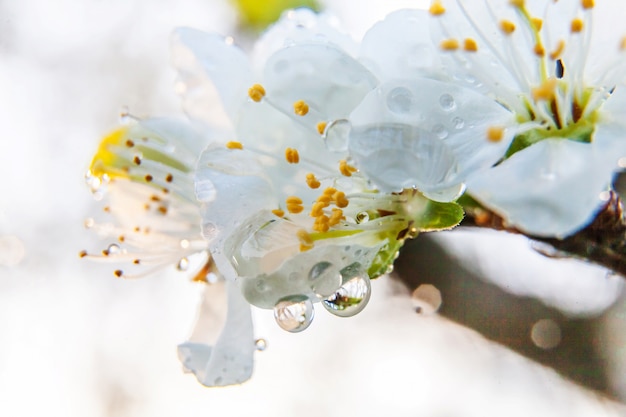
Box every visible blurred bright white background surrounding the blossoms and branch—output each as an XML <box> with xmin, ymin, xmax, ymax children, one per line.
<box><xmin>0</xmin><ymin>0</ymin><xmax>626</xmax><ymax>417</ymax></box>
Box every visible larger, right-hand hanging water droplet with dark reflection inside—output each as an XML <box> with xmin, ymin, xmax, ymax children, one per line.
<box><xmin>322</xmin><ymin>264</ymin><xmax>371</xmax><ymax>317</ymax></box>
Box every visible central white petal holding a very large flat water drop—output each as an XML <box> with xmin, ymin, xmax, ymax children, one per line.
<box><xmin>349</xmin><ymin>78</ymin><xmax>514</xmax><ymax>200</ymax></box>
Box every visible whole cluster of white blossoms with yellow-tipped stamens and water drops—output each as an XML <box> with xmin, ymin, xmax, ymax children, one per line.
<box><xmin>81</xmin><ymin>0</ymin><xmax>626</xmax><ymax>386</ymax></box>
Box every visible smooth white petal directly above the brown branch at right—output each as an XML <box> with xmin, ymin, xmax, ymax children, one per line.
<box><xmin>468</xmin><ymin>139</ymin><xmax>613</xmax><ymax>237</ymax></box>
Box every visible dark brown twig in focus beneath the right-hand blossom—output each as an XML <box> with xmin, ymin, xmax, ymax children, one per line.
<box><xmin>461</xmin><ymin>191</ymin><xmax>626</xmax><ymax>277</ymax></box>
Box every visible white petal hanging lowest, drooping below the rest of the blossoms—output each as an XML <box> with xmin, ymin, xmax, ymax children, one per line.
<box><xmin>178</xmin><ymin>282</ymin><xmax>255</xmax><ymax>387</ymax></box>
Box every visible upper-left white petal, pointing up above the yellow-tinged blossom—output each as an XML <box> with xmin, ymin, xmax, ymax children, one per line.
<box><xmin>172</xmin><ymin>28</ymin><xmax>253</xmax><ymax>128</ymax></box>
